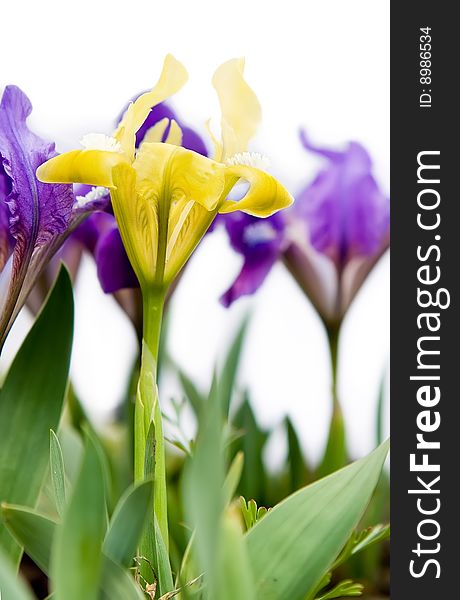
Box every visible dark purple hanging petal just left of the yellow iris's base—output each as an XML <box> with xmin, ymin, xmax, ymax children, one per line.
<box><xmin>95</xmin><ymin>225</ymin><xmax>139</xmax><ymax>294</ymax></box>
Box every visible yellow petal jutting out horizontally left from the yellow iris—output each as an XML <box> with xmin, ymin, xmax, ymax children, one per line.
<box><xmin>37</xmin><ymin>150</ymin><xmax>126</xmax><ymax>188</ymax></box>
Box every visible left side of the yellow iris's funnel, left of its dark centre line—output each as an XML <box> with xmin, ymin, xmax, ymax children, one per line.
<box><xmin>110</xmin><ymin>164</ymin><xmax>158</xmax><ymax>287</ymax></box>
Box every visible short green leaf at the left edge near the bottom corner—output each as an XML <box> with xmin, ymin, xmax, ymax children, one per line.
<box><xmin>2</xmin><ymin>504</ymin><xmax>57</xmax><ymax>575</ymax></box>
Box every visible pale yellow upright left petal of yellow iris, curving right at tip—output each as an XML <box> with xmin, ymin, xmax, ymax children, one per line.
<box><xmin>114</xmin><ymin>54</ymin><xmax>188</xmax><ymax>157</ymax></box>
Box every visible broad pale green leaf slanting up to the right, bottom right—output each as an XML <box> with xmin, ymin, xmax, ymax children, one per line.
<box><xmin>246</xmin><ymin>443</ymin><xmax>388</xmax><ymax>600</ymax></box>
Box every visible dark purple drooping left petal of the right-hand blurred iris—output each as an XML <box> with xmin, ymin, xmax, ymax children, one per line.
<box><xmin>221</xmin><ymin>212</ymin><xmax>285</xmax><ymax>306</ymax></box>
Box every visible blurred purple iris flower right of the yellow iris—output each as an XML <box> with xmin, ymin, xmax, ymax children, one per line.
<box><xmin>221</xmin><ymin>132</ymin><xmax>390</xmax><ymax>324</ymax></box>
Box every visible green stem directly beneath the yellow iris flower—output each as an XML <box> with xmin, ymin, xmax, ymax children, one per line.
<box><xmin>134</xmin><ymin>287</ymin><xmax>168</xmax><ymax>548</ymax></box>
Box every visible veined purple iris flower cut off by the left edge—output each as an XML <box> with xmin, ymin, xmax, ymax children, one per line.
<box><xmin>0</xmin><ymin>86</ymin><xmax>74</xmax><ymax>347</ymax></box>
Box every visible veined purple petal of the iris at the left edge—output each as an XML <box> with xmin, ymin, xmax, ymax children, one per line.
<box><xmin>0</xmin><ymin>86</ymin><xmax>74</xmax><ymax>272</ymax></box>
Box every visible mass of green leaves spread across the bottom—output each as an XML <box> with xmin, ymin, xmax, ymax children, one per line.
<box><xmin>0</xmin><ymin>284</ymin><xmax>389</xmax><ymax>600</ymax></box>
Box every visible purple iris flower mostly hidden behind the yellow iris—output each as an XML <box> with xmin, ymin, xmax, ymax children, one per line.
<box><xmin>72</xmin><ymin>98</ymin><xmax>207</xmax><ymax>294</ymax></box>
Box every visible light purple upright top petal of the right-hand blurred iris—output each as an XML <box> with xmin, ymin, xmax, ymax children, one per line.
<box><xmin>294</xmin><ymin>132</ymin><xmax>390</xmax><ymax>266</ymax></box>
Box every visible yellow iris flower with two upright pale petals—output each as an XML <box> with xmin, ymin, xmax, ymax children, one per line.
<box><xmin>37</xmin><ymin>55</ymin><xmax>292</xmax><ymax>291</ymax></box>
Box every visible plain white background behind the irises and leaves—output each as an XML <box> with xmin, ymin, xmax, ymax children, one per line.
<box><xmin>0</xmin><ymin>0</ymin><xmax>389</xmax><ymax>459</ymax></box>
